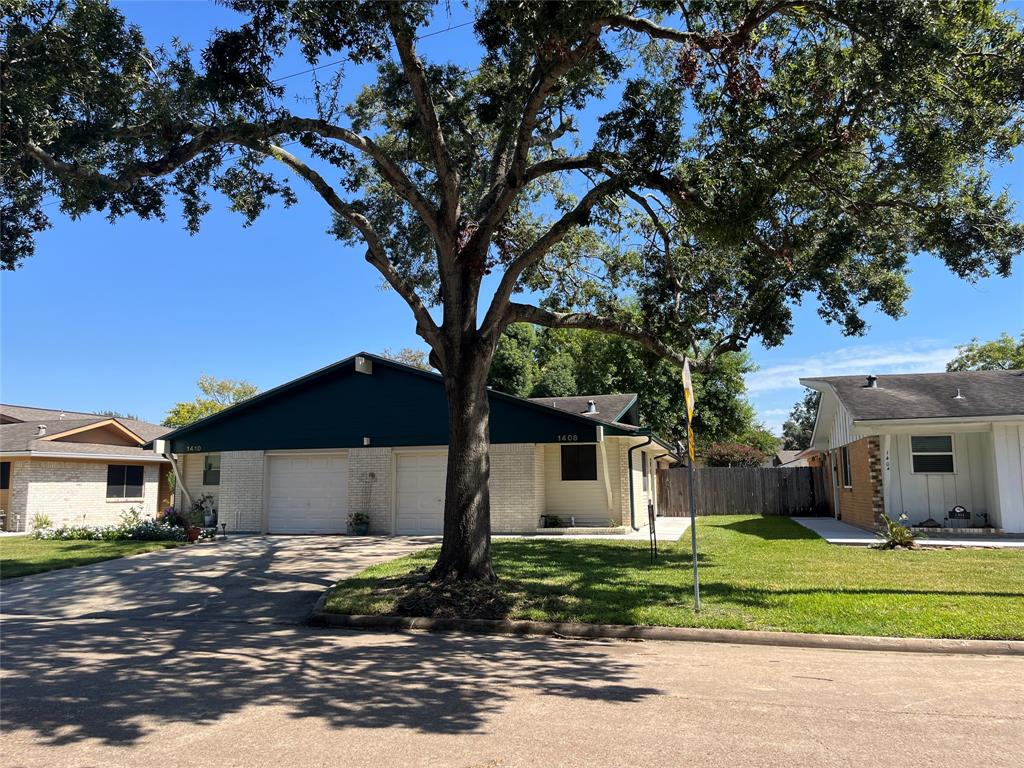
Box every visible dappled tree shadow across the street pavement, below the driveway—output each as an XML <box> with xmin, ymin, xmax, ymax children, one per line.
<box><xmin>2</xmin><ymin>617</ymin><xmax>658</xmax><ymax>745</ymax></box>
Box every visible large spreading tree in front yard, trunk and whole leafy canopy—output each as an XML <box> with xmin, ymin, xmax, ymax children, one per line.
<box><xmin>0</xmin><ymin>0</ymin><xmax>1024</xmax><ymax>580</ymax></box>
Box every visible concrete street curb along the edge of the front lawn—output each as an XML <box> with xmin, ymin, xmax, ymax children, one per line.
<box><xmin>309</xmin><ymin>606</ymin><xmax>1024</xmax><ymax>656</ymax></box>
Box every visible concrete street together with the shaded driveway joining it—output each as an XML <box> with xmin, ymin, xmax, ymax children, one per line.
<box><xmin>0</xmin><ymin>539</ymin><xmax>1024</xmax><ymax>768</ymax></box>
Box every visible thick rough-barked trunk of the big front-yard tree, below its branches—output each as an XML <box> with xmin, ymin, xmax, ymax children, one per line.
<box><xmin>430</xmin><ymin>353</ymin><xmax>495</xmax><ymax>582</ymax></box>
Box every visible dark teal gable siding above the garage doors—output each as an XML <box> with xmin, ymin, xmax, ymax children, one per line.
<box><xmin>160</xmin><ymin>357</ymin><xmax>623</xmax><ymax>454</ymax></box>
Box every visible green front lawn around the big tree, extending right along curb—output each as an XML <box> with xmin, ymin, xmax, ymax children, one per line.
<box><xmin>327</xmin><ymin>516</ymin><xmax>1024</xmax><ymax>639</ymax></box>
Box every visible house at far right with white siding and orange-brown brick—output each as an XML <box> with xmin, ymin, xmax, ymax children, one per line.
<box><xmin>801</xmin><ymin>371</ymin><xmax>1024</xmax><ymax>532</ymax></box>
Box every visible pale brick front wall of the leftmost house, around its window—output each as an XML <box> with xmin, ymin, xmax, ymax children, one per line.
<box><xmin>7</xmin><ymin>459</ymin><xmax>165</xmax><ymax>530</ymax></box>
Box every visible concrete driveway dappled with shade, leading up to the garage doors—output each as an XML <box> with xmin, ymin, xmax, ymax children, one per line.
<box><xmin>0</xmin><ymin>536</ymin><xmax>439</xmax><ymax>624</ymax></box>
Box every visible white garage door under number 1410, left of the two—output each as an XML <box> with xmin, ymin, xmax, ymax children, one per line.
<box><xmin>268</xmin><ymin>455</ymin><xmax>348</xmax><ymax>534</ymax></box>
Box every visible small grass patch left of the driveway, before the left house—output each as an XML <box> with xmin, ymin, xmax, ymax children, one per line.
<box><xmin>0</xmin><ymin>536</ymin><xmax>182</xmax><ymax>579</ymax></box>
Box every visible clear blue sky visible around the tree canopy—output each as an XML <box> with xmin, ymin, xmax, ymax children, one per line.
<box><xmin>0</xmin><ymin>1</ymin><xmax>1024</xmax><ymax>428</ymax></box>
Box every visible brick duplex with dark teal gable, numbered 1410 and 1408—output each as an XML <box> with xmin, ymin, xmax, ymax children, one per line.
<box><xmin>153</xmin><ymin>353</ymin><xmax>672</xmax><ymax>535</ymax></box>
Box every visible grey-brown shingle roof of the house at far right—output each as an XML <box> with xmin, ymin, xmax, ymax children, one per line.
<box><xmin>801</xmin><ymin>371</ymin><xmax>1024</xmax><ymax>421</ymax></box>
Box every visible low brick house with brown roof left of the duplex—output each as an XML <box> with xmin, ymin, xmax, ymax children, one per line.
<box><xmin>0</xmin><ymin>404</ymin><xmax>170</xmax><ymax>531</ymax></box>
